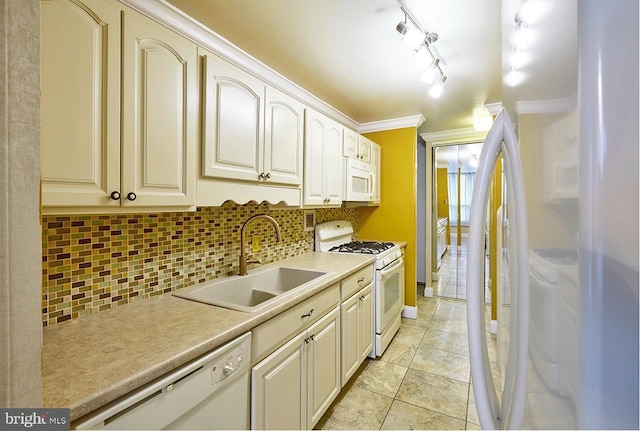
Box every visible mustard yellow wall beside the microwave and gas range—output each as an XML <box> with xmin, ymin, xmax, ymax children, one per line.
<box><xmin>358</xmin><ymin>127</ymin><xmax>418</xmax><ymax>306</ymax></box>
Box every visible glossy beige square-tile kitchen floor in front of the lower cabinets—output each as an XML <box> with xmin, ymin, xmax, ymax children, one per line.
<box><xmin>316</xmin><ymin>295</ymin><xmax>495</xmax><ymax>430</ymax></box>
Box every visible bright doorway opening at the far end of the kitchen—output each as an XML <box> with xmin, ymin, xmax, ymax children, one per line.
<box><xmin>431</xmin><ymin>143</ymin><xmax>482</xmax><ymax>299</ymax></box>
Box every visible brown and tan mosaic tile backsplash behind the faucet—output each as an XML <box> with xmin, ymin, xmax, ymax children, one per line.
<box><xmin>42</xmin><ymin>202</ymin><xmax>358</xmax><ymax>326</ymax></box>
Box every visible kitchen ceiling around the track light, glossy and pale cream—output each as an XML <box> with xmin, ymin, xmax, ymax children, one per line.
<box><xmin>168</xmin><ymin>0</ymin><xmax>501</xmax><ymax>133</ymax></box>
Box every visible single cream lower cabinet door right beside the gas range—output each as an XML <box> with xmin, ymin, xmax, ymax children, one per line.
<box><xmin>340</xmin><ymin>283</ymin><xmax>374</xmax><ymax>386</ymax></box>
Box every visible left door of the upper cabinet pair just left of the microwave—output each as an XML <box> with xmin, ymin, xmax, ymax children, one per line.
<box><xmin>303</xmin><ymin>109</ymin><xmax>327</xmax><ymax>205</ymax></box>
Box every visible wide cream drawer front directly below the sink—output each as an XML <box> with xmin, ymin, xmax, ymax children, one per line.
<box><xmin>251</xmin><ymin>283</ymin><xmax>340</xmax><ymax>364</ymax></box>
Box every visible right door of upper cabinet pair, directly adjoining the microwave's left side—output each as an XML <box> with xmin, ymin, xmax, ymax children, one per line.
<box><xmin>324</xmin><ymin>119</ymin><xmax>344</xmax><ymax>205</ymax></box>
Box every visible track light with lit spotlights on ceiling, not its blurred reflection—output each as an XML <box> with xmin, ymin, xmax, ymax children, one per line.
<box><xmin>396</xmin><ymin>6</ymin><xmax>447</xmax><ymax>99</ymax></box>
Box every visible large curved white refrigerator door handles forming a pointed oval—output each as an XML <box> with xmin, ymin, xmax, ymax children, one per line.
<box><xmin>467</xmin><ymin>109</ymin><xmax>529</xmax><ymax>429</ymax></box>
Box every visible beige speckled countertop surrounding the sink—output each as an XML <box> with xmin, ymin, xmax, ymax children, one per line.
<box><xmin>42</xmin><ymin>252</ymin><xmax>375</xmax><ymax>420</ymax></box>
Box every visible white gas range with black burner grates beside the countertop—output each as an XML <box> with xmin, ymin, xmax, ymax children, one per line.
<box><xmin>315</xmin><ymin>220</ymin><xmax>404</xmax><ymax>356</ymax></box>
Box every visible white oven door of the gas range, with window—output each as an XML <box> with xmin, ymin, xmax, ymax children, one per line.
<box><xmin>376</xmin><ymin>258</ymin><xmax>404</xmax><ymax>334</ymax></box>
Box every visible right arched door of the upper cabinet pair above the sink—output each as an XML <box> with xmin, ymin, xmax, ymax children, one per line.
<box><xmin>263</xmin><ymin>87</ymin><xmax>304</xmax><ymax>186</ymax></box>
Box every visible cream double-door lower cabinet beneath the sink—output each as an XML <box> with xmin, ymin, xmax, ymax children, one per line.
<box><xmin>251</xmin><ymin>307</ymin><xmax>341</xmax><ymax>429</ymax></box>
